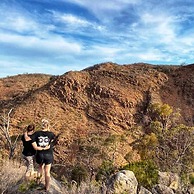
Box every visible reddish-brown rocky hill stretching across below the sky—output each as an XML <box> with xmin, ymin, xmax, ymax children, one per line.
<box><xmin>0</xmin><ymin>63</ymin><xmax>194</xmax><ymax>175</ymax></box>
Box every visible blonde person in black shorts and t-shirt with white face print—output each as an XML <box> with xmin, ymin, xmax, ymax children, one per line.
<box><xmin>32</xmin><ymin>119</ymin><xmax>55</xmax><ymax>191</ymax></box>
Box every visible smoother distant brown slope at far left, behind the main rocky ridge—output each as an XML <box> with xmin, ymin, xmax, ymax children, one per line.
<box><xmin>0</xmin><ymin>74</ymin><xmax>51</xmax><ymax>112</ymax></box>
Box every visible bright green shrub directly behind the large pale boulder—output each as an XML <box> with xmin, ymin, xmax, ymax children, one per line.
<box><xmin>122</xmin><ymin>161</ymin><xmax>158</xmax><ymax>189</ymax></box>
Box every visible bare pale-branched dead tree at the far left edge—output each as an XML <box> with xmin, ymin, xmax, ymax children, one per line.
<box><xmin>0</xmin><ymin>109</ymin><xmax>19</xmax><ymax>159</ymax></box>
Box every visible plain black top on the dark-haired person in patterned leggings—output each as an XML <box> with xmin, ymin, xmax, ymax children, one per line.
<box><xmin>21</xmin><ymin>135</ymin><xmax>36</xmax><ymax>156</ymax></box>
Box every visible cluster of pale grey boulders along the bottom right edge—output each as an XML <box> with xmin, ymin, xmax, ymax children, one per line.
<box><xmin>106</xmin><ymin>170</ymin><xmax>194</xmax><ymax>194</ymax></box>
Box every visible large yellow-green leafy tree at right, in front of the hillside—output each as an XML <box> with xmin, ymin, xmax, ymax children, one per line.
<box><xmin>136</xmin><ymin>104</ymin><xmax>194</xmax><ymax>173</ymax></box>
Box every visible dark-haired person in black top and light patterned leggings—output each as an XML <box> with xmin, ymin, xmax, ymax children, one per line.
<box><xmin>21</xmin><ymin>124</ymin><xmax>36</xmax><ymax>174</ymax></box>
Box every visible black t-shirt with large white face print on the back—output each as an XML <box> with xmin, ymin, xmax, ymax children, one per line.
<box><xmin>31</xmin><ymin>131</ymin><xmax>55</xmax><ymax>154</ymax></box>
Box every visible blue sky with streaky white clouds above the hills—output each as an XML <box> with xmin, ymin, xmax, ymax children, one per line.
<box><xmin>0</xmin><ymin>0</ymin><xmax>194</xmax><ymax>77</ymax></box>
